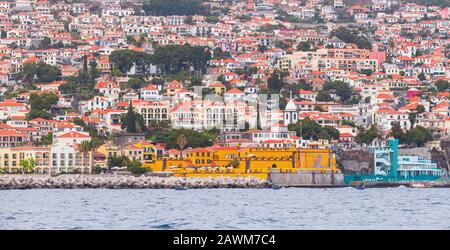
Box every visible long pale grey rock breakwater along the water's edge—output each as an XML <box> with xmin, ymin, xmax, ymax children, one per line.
<box><xmin>0</xmin><ymin>175</ymin><xmax>269</xmax><ymax>189</ymax></box>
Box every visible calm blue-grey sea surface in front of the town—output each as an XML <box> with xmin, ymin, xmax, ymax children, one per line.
<box><xmin>0</xmin><ymin>187</ymin><xmax>450</xmax><ymax>229</ymax></box>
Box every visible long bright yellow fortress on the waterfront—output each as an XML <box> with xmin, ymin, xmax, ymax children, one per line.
<box><xmin>135</xmin><ymin>144</ymin><xmax>339</xmax><ymax>179</ymax></box>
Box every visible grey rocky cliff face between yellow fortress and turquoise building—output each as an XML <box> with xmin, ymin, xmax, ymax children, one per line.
<box><xmin>337</xmin><ymin>150</ymin><xmax>373</xmax><ymax>174</ymax></box>
